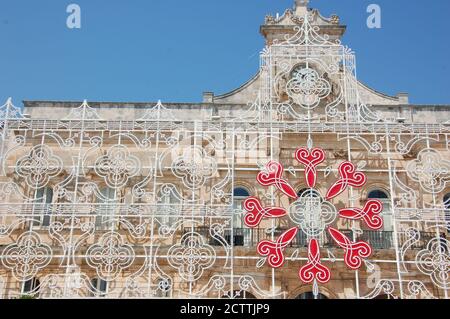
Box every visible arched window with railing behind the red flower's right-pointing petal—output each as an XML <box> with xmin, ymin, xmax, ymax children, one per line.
<box><xmin>368</xmin><ymin>189</ymin><xmax>394</xmax><ymax>249</ymax></box>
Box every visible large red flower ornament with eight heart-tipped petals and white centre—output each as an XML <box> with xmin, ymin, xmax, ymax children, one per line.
<box><xmin>243</xmin><ymin>148</ymin><xmax>383</xmax><ymax>285</ymax></box>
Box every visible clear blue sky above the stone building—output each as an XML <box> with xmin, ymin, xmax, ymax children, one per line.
<box><xmin>0</xmin><ymin>0</ymin><xmax>450</xmax><ymax>106</ymax></box>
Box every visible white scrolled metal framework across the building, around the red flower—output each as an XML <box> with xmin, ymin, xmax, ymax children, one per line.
<box><xmin>0</xmin><ymin>12</ymin><xmax>450</xmax><ymax>299</ymax></box>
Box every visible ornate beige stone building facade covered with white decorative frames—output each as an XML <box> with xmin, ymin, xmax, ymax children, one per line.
<box><xmin>0</xmin><ymin>0</ymin><xmax>450</xmax><ymax>299</ymax></box>
